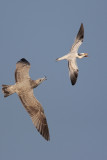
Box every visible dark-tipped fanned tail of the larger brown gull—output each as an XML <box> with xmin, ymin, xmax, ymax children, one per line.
<box><xmin>2</xmin><ymin>84</ymin><xmax>15</xmax><ymax>97</ymax></box>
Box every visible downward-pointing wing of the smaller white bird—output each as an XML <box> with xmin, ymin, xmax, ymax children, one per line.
<box><xmin>68</xmin><ymin>60</ymin><xmax>78</xmax><ymax>85</ymax></box>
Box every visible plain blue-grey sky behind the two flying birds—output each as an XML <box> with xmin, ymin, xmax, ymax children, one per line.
<box><xmin>0</xmin><ymin>0</ymin><xmax>107</xmax><ymax>160</ymax></box>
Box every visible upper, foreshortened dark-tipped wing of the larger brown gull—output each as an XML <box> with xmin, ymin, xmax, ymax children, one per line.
<box><xmin>15</xmin><ymin>58</ymin><xmax>30</xmax><ymax>82</ymax></box>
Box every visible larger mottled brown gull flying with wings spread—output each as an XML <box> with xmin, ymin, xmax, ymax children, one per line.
<box><xmin>2</xmin><ymin>58</ymin><xmax>50</xmax><ymax>140</ymax></box>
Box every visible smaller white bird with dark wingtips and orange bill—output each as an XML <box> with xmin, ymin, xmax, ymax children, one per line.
<box><xmin>56</xmin><ymin>24</ymin><xmax>88</xmax><ymax>85</ymax></box>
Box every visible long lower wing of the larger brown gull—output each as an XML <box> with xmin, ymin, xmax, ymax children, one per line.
<box><xmin>19</xmin><ymin>90</ymin><xmax>50</xmax><ymax>140</ymax></box>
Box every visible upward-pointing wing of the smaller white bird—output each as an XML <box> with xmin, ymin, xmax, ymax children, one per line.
<box><xmin>71</xmin><ymin>23</ymin><xmax>84</xmax><ymax>54</ymax></box>
